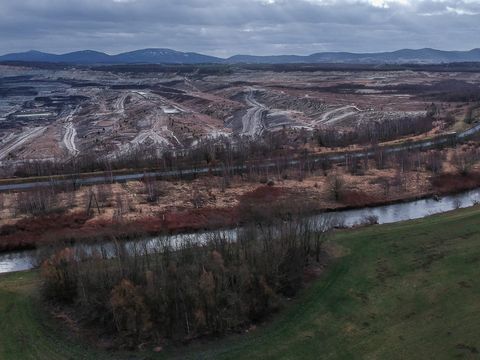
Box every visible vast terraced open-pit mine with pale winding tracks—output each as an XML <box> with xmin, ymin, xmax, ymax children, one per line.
<box><xmin>0</xmin><ymin>65</ymin><xmax>480</xmax><ymax>170</ymax></box>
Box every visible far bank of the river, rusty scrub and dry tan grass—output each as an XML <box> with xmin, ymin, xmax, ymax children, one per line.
<box><xmin>0</xmin><ymin>165</ymin><xmax>480</xmax><ymax>253</ymax></box>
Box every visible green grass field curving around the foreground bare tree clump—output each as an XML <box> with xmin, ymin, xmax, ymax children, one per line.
<box><xmin>0</xmin><ymin>207</ymin><xmax>480</xmax><ymax>360</ymax></box>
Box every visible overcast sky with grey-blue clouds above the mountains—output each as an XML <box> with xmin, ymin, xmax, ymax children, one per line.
<box><xmin>0</xmin><ymin>0</ymin><xmax>480</xmax><ymax>56</ymax></box>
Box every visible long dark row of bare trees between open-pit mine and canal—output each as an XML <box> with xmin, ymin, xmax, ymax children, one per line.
<box><xmin>0</xmin><ymin>116</ymin><xmax>458</xmax><ymax>186</ymax></box>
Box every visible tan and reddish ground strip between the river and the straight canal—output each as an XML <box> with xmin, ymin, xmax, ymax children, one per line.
<box><xmin>0</xmin><ymin>150</ymin><xmax>480</xmax><ymax>251</ymax></box>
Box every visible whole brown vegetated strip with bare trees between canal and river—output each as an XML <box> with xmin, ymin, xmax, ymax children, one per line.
<box><xmin>0</xmin><ymin>143</ymin><xmax>480</xmax><ymax>251</ymax></box>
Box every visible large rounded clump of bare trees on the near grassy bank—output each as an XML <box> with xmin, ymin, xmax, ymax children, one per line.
<box><xmin>42</xmin><ymin>212</ymin><xmax>331</xmax><ymax>346</ymax></box>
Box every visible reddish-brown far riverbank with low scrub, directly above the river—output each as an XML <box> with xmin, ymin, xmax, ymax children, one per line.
<box><xmin>0</xmin><ymin>167</ymin><xmax>480</xmax><ymax>253</ymax></box>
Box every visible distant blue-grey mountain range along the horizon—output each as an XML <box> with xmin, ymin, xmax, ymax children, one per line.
<box><xmin>0</xmin><ymin>48</ymin><xmax>480</xmax><ymax>65</ymax></box>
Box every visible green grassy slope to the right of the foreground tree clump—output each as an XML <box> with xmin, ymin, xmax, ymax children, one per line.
<box><xmin>189</xmin><ymin>208</ymin><xmax>480</xmax><ymax>359</ymax></box>
